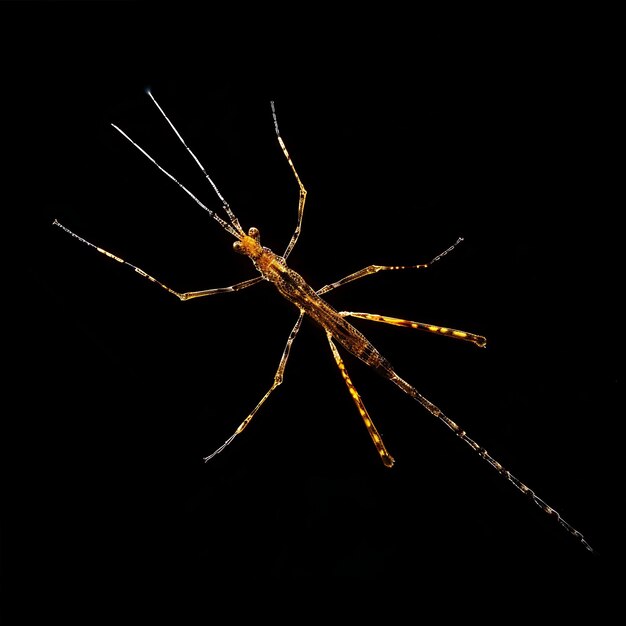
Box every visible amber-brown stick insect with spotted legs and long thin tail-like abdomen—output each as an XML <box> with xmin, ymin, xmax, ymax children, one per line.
<box><xmin>53</xmin><ymin>90</ymin><xmax>593</xmax><ymax>552</ymax></box>
